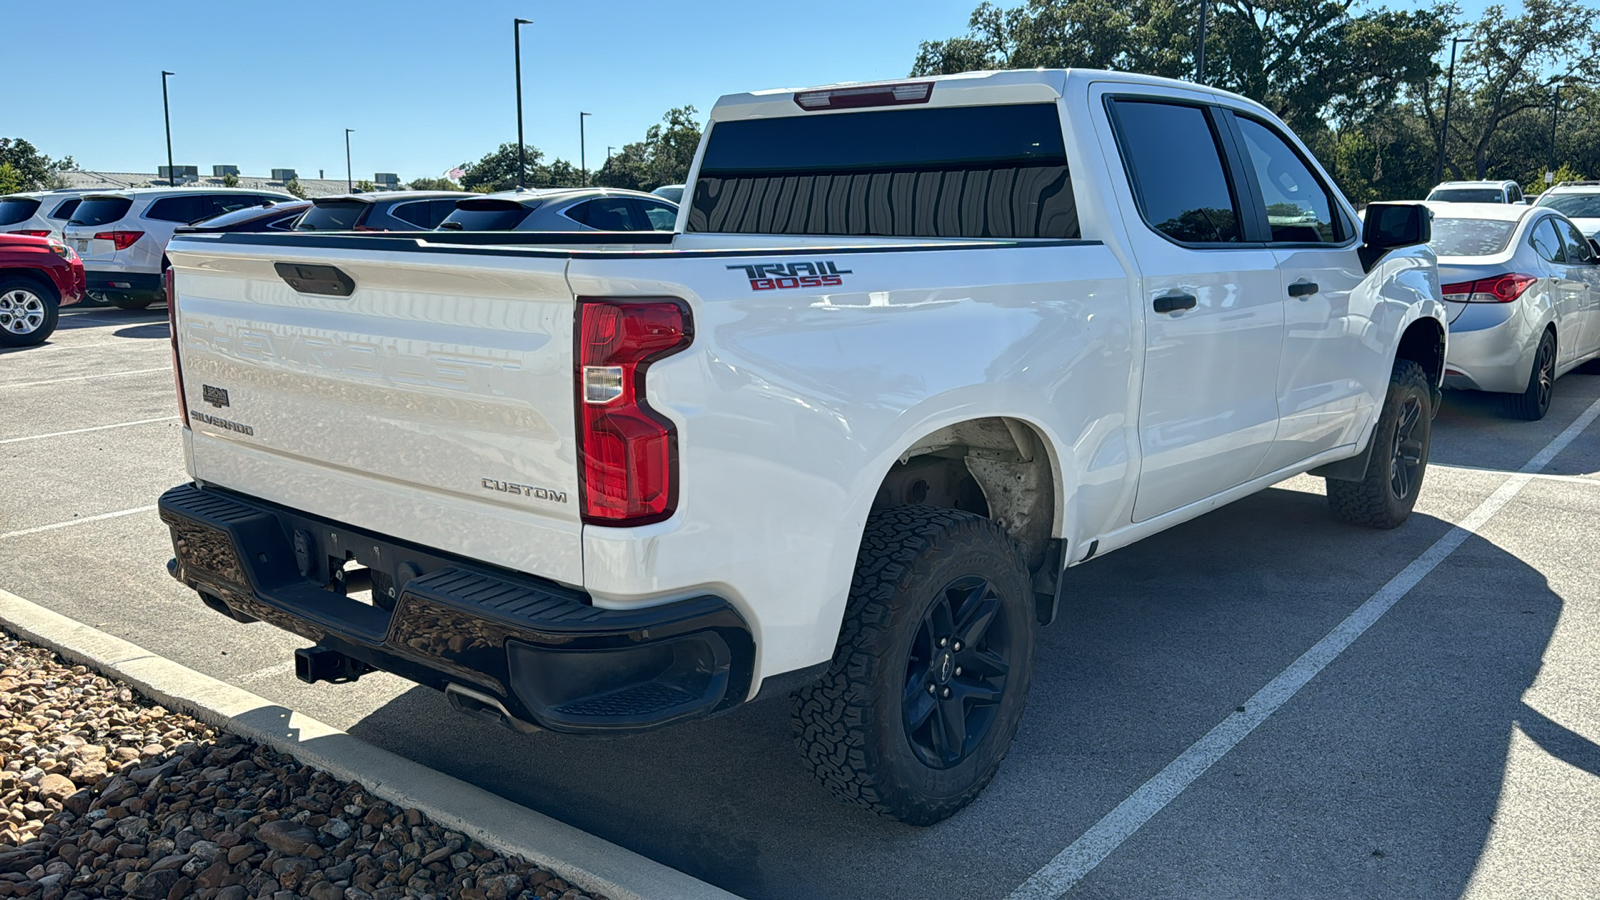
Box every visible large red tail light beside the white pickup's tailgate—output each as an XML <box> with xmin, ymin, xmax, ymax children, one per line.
<box><xmin>576</xmin><ymin>298</ymin><xmax>693</xmax><ymax>525</ymax></box>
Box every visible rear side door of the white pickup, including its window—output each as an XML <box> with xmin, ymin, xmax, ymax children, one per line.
<box><xmin>1109</xmin><ymin>96</ymin><xmax>1283</xmax><ymax>522</ymax></box>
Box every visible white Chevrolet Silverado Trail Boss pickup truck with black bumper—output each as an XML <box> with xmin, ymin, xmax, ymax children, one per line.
<box><xmin>160</xmin><ymin>70</ymin><xmax>1446</xmax><ymax>823</ymax></box>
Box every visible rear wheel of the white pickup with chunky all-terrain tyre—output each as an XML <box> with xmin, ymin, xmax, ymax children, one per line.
<box><xmin>790</xmin><ymin>506</ymin><xmax>1034</xmax><ymax>825</ymax></box>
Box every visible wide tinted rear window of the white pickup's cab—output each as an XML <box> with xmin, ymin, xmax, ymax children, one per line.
<box><xmin>688</xmin><ymin>104</ymin><xmax>1078</xmax><ymax>239</ymax></box>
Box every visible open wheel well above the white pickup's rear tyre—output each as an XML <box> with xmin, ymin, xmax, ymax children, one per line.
<box><xmin>872</xmin><ymin>416</ymin><xmax>1059</xmax><ymax>570</ymax></box>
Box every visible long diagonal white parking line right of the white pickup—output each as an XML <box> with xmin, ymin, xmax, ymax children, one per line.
<box><xmin>1011</xmin><ymin>393</ymin><xmax>1600</xmax><ymax>900</ymax></box>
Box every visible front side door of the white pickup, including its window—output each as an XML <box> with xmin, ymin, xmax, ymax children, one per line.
<box><xmin>1226</xmin><ymin>112</ymin><xmax>1387</xmax><ymax>474</ymax></box>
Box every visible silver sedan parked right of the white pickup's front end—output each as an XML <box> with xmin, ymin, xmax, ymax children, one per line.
<box><xmin>1427</xmin><ymin>203</ymin><xmax>1600</xmax><ymax>420</ymax></box>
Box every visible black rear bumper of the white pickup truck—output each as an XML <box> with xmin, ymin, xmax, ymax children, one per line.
<box><xmin>160</xmin><ymin>485</ymin><xmax>755</xmax><ymax>733</ymax></box>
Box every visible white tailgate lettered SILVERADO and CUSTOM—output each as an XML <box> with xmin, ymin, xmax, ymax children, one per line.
<box><xmin>170</xmin><ymin>239</ymin><xmax>582</xmax><ymax>585</ymax></box>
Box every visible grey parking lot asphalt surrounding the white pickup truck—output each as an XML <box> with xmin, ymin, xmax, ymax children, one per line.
<box><xmin>9</xmin><ymin>309</ymin><xmax>1600</xmax><ymax>900</ymax></box>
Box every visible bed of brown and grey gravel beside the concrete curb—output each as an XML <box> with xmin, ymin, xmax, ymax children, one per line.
<box><xmin>0</xmin><ymin>633</ymin><xmax>603</xmax><ymax>900</ymax></box>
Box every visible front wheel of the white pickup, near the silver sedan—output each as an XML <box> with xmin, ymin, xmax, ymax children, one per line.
<box><xmin>1328</xmin><ymin>359</ymin><xmax>1434</xmax><ymax>528</ymax></box>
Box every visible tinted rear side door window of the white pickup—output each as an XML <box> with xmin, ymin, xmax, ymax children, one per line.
<box><xmin>1112</xmin><ymin>101</ymin><xmax>1243</xmax><ymax>243</ymax></box>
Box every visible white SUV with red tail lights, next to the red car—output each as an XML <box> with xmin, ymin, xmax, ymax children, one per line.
<box><xmin>62</xmin><ymin>187</ymin><xmax>294</xmax><ymax>309</ymax></box>
